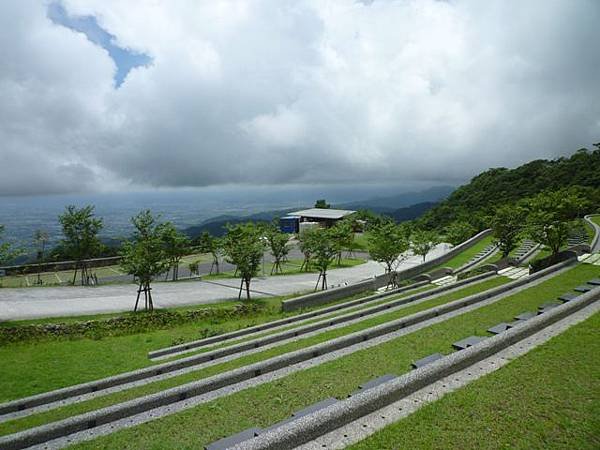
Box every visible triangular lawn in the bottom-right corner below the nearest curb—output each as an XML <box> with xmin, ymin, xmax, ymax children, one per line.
<box><xmin>350</xmin><ymin>313</ymin><xmax>600</xmax><ymax>450</ymax></box>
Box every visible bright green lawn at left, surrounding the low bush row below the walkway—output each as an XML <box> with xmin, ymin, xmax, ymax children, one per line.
<box><xmin>0</xmin><ymin>295</ymin><xmax>318</xmax><ymax>402</ymax></box>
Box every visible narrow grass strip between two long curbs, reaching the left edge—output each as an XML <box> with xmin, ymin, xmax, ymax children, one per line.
<box><xmin>0</xmin><ymin>277</ymin><xmax>510</xmax><ymax>435</ymax></box>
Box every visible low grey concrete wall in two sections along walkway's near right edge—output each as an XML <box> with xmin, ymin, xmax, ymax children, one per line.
<box><xmin>281</xmin><ymin>229</ymin><xmax>492</xmax><ymax>311</ymax></box>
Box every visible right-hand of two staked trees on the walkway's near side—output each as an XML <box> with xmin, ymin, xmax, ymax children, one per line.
<box><xmin>223</xmin><ymin>222</ymin><xmax>265</xmax><ymax>300</ymax></box>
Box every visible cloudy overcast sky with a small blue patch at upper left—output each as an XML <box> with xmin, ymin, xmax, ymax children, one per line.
<box><xmin>0</xmin><ymin>0</ymin><xmax>600</xmax><ymax>195</ymax></box>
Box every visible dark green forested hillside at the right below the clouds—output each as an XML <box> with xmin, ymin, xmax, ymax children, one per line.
<box><xmin>419</xmin><ymin>144</ymin><xmax>600</xmax><ymax>229</ymax></box>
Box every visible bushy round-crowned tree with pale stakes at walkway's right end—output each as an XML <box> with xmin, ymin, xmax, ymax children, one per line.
<box><xmin>367</xmin><ymin>222</ymin><xmax>410</xmax><ymax>273</ymax></box>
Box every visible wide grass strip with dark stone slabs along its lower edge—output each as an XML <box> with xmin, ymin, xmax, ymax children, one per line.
<box><xmin>59</xmin><ymin>264</ymin><xmax>598</xmax><ymax>449</ymax></box>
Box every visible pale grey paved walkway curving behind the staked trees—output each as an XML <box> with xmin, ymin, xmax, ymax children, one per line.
<box><xmin>0</xmin><ymin>244</ymin><xmax>449</xmax><ymax>321</ymax></box>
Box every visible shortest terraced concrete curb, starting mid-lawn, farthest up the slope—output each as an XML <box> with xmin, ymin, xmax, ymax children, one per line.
<box><xmin>148</xmin><ymin>280</ymin><xmax>429</xmax><ymax>359</ymax></box>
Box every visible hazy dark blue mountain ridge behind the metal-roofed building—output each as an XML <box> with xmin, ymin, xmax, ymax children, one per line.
<box><xmin>183</xmin><ymin>186</ymin><xmax>454</xmax><ymax>237</ymax></box>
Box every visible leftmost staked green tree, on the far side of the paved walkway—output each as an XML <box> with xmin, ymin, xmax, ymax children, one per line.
<box><xmin>58</xmin><ymin>205</ymin><xmax>103</xmax><ymax>285</ymax></box>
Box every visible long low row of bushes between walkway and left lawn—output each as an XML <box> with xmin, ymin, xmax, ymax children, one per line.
<box><xmin>0</xmin><ymin>303</ymin><xmax>264</xmax><ymax>345</ymax></box>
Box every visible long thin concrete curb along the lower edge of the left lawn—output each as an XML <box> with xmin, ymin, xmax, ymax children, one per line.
<box><xmin>0</xmin><ymin>273</ymin><xmax>493</xmax><ymax>415</ymax></box>
